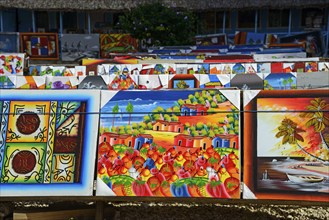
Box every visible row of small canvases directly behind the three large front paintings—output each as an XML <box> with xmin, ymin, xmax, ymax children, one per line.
<box><xmin>0</xmin><ymin>72</ymin><xmax>329</xmax><ymax>90</ymax></box>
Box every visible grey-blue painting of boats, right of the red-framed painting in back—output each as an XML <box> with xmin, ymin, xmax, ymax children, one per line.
<box><xmin>61</xmin><ymin>34</ymin><xmax>100</xmax><ymax>62</ymax></box>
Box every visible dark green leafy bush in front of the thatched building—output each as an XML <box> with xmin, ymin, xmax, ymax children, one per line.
<box><xmin>118</xmin><ymin>2</ymin><xmax>196</xmax><ymax>46</ymax></box>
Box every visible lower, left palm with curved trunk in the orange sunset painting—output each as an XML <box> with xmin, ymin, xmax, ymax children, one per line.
<box><xmin>275</xmin><ymin>118</ymin><xmax>328</xmax><ymax>162</ymax></box>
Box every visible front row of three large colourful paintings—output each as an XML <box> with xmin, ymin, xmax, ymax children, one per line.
<box><xmin>0</xmin><ymin>89</ymin><xmax>329</xmax><ymax>202</ymax></box>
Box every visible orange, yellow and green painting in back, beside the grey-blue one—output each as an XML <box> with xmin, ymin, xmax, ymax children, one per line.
<box><xmin>100</xmin><ymin>34</ymin><xmax>138</xmax><ymax>58</ymax></box>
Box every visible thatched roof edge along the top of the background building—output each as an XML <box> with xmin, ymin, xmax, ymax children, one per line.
<box><xmin>0</xmin><ymin>0</ymin><xmax>329</xmax><ymax>11</ymax></box>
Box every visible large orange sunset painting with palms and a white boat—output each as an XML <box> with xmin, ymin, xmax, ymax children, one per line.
<box><xmin>243</xmin><ymin>89</ymin><xmax>329</xmax><ymax>202</ymax></box>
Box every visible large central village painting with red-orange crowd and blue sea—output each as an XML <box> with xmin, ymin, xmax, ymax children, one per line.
<box><xmin>96</xmin><ymin>90</ymin><xmax>241</xmax><ymax>199</ymax></box>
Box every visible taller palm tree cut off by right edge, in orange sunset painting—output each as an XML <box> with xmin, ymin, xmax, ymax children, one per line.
<box><xmin>300</xmin><ymin>98</ymin><xmax>329</xmax><ymax>150</ymax></box>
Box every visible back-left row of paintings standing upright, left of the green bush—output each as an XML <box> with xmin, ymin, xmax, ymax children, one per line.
<box><xmin>0</xmin><ymin>32</ymin><xmax>138</xmax><ymax>62</ymax></box>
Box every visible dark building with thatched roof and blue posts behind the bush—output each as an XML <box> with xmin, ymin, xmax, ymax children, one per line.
<box><xmin>0</xmin><ymin>0</ymin><xmax>329</xmax><ymax>53</ymax></box>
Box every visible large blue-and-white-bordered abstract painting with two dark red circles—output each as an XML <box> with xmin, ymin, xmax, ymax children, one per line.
<box><xmin>0</xmin><ymin>90</ymin><xmax>100</xmax><ymax>196</ymax></box>
